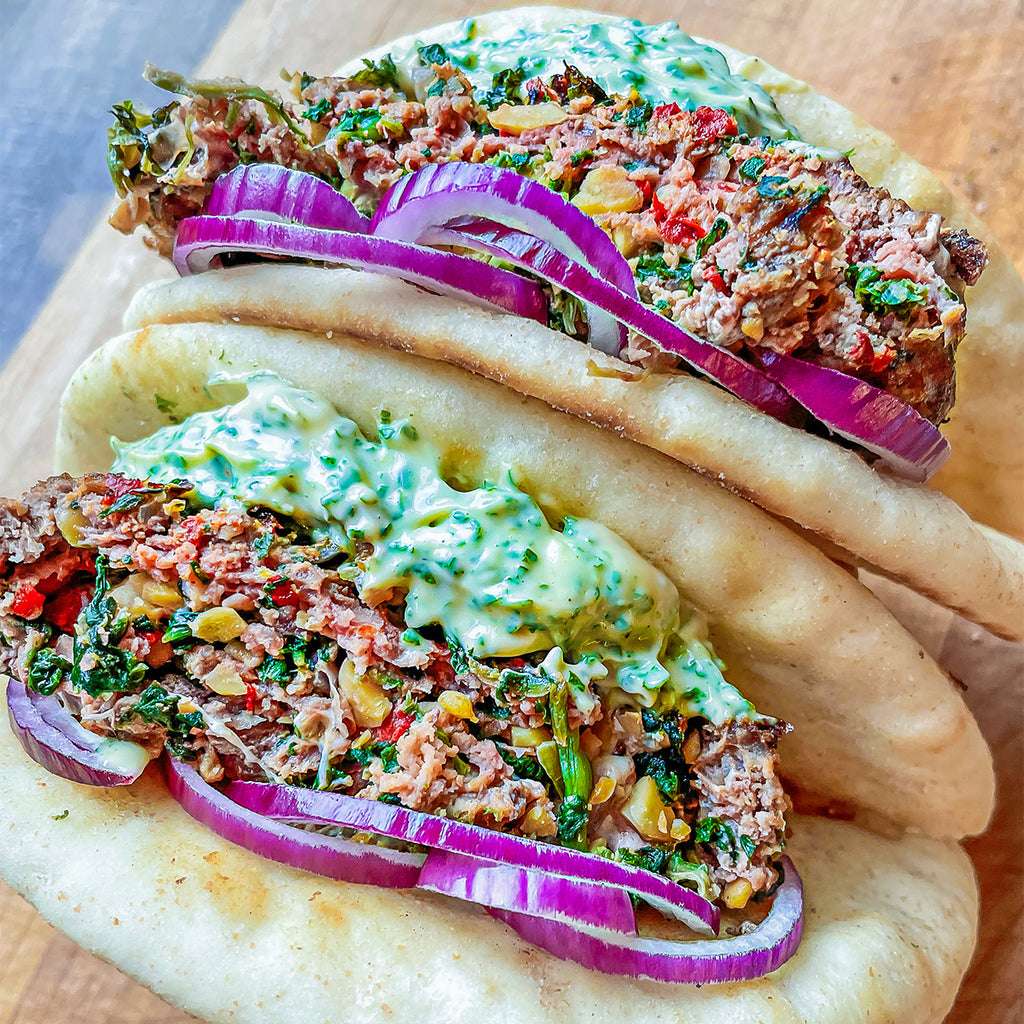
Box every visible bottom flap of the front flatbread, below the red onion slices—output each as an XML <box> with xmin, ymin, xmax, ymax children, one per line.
<box><xmin>0</xmin><ymin>716</ymin><xmax>978</xmax><ymax>1024</ymax></box>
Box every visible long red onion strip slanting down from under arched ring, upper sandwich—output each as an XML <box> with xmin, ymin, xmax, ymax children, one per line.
<box><xmin>417</xmin><ymin>217</ymin><xmax>798</xmax><ymax>421</ymax></box>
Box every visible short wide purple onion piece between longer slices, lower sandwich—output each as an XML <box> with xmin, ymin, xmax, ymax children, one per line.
<box><xmin>418</xmin><ymin>850</ymin><xmax>637</xmax><ymax>935</ymax></box>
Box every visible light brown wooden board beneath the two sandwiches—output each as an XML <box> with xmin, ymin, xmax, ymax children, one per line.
<box><xmin>0</xmin><ymin>0</ymin><xmax>1024</xmax><ymax>1024</ymax></box>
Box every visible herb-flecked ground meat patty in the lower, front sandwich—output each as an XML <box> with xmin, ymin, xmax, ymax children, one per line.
<box><xmin>0</xmin><ymin>474</ymin><xmax>785</xmax><ymax>905</ymax></box>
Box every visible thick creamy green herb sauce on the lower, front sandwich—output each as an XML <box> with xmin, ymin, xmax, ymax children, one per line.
<box><xmin>113</xmin><ymin>374</ymin><xmax>754</xmax><ymax>723</ymax></box>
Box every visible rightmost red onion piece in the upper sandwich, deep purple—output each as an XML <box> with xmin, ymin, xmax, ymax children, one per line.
<box><xmin>754</xmin><ymin>348</ymin><xmax>949</xmax><ymax>483</ymax></box>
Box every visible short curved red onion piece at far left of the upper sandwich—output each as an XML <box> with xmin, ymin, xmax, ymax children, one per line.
<box><xmin>203</xmin><ymin>164</ymin><xmax>370</xmax><ymax>233</ymax></box>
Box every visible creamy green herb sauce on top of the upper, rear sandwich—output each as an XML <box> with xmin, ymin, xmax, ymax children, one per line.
<box><xmin>392</xmin><ymin>13</ymin><xmax>798</xmax><ymax>138</ymax></box>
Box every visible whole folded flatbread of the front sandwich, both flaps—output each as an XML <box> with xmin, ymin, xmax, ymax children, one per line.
<box><xmin>0</xmin><ymin>315</ymin><xmax>991</xmax><ymax>1022</ymax></box>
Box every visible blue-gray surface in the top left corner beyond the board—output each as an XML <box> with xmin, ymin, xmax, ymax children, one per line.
<box><xmin>0</xmin><ymin>0</ymin><xmax>240</xmax><ymax>367</ymax></box>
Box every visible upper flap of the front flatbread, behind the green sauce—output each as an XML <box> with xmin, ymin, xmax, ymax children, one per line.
<box><xmin>56</xmin><ymin>324</ymin><xmax>993</xmax><ymax>837</ymax></box>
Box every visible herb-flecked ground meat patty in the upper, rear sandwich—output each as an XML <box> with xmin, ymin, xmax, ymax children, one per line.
<box><xmin>112</xmin><ymin>65</ymin><xmax>988</xmax><ymax>423</ymax></box>
